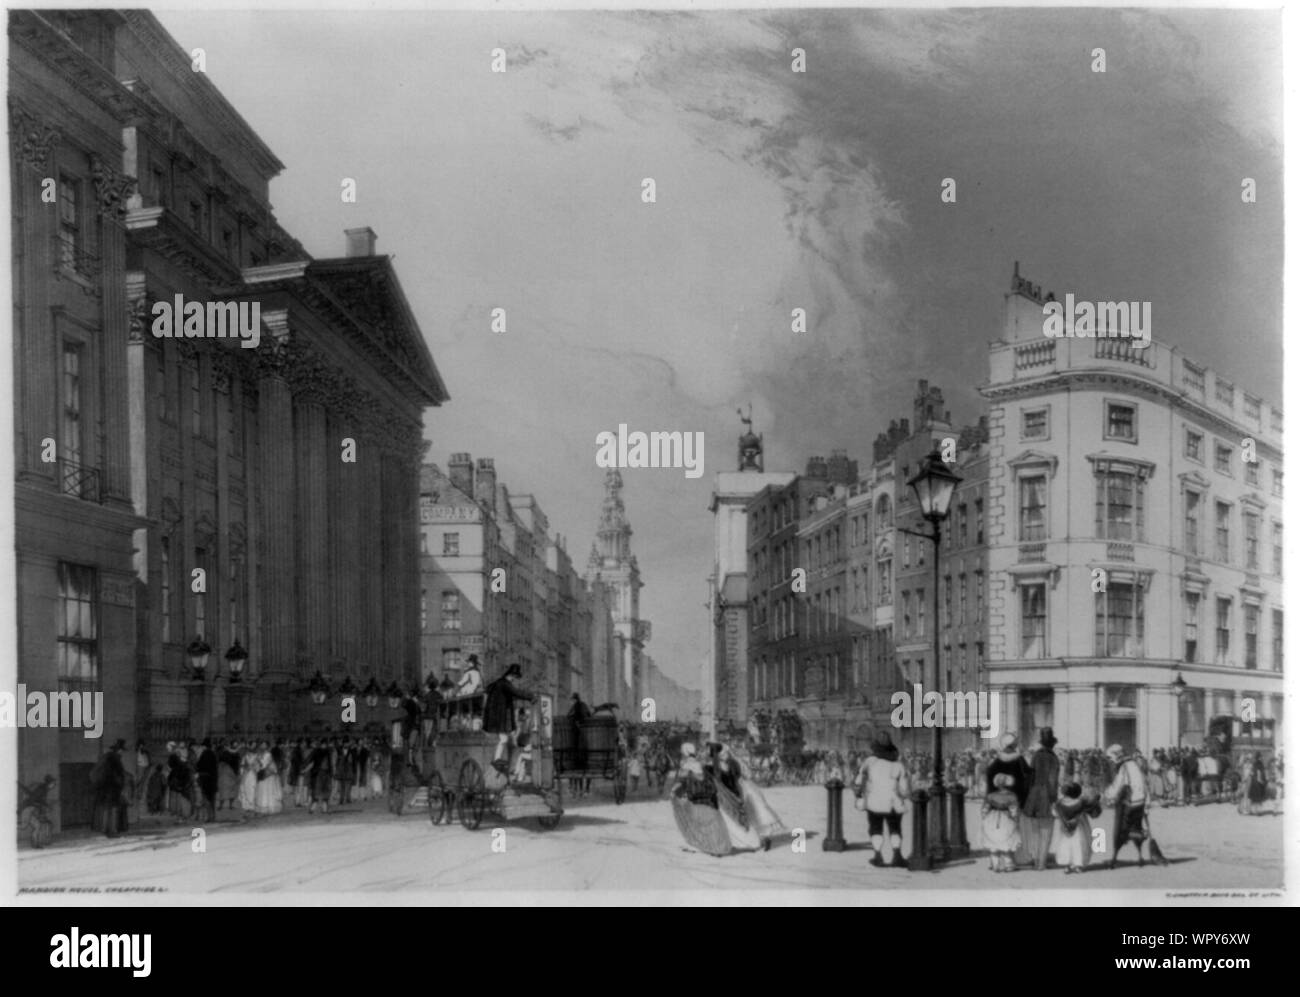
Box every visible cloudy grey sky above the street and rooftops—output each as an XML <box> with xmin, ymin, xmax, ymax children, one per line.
<box><xmin>160</xmin><ymin>9</ymin><xmax>1282</xmax><ymax>685</ymax></box>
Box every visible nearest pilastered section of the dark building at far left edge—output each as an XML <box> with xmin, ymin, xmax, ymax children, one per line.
<box><xmin>3</xmin><ymin>10</ymin><xmax>146</xmax><ymax>829</ymax></box>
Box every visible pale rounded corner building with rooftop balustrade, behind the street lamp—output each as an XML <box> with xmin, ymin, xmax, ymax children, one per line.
<box><xmin>982</xmin><ymin>268</ymin><xmax>1284</xmax><ymax>753</ymax></box>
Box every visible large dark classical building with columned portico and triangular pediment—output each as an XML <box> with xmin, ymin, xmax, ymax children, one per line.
<box><xmin>10</xmin><ymin>10</ymin><xmax>447</xmax><ymax>823</ymax></box>
